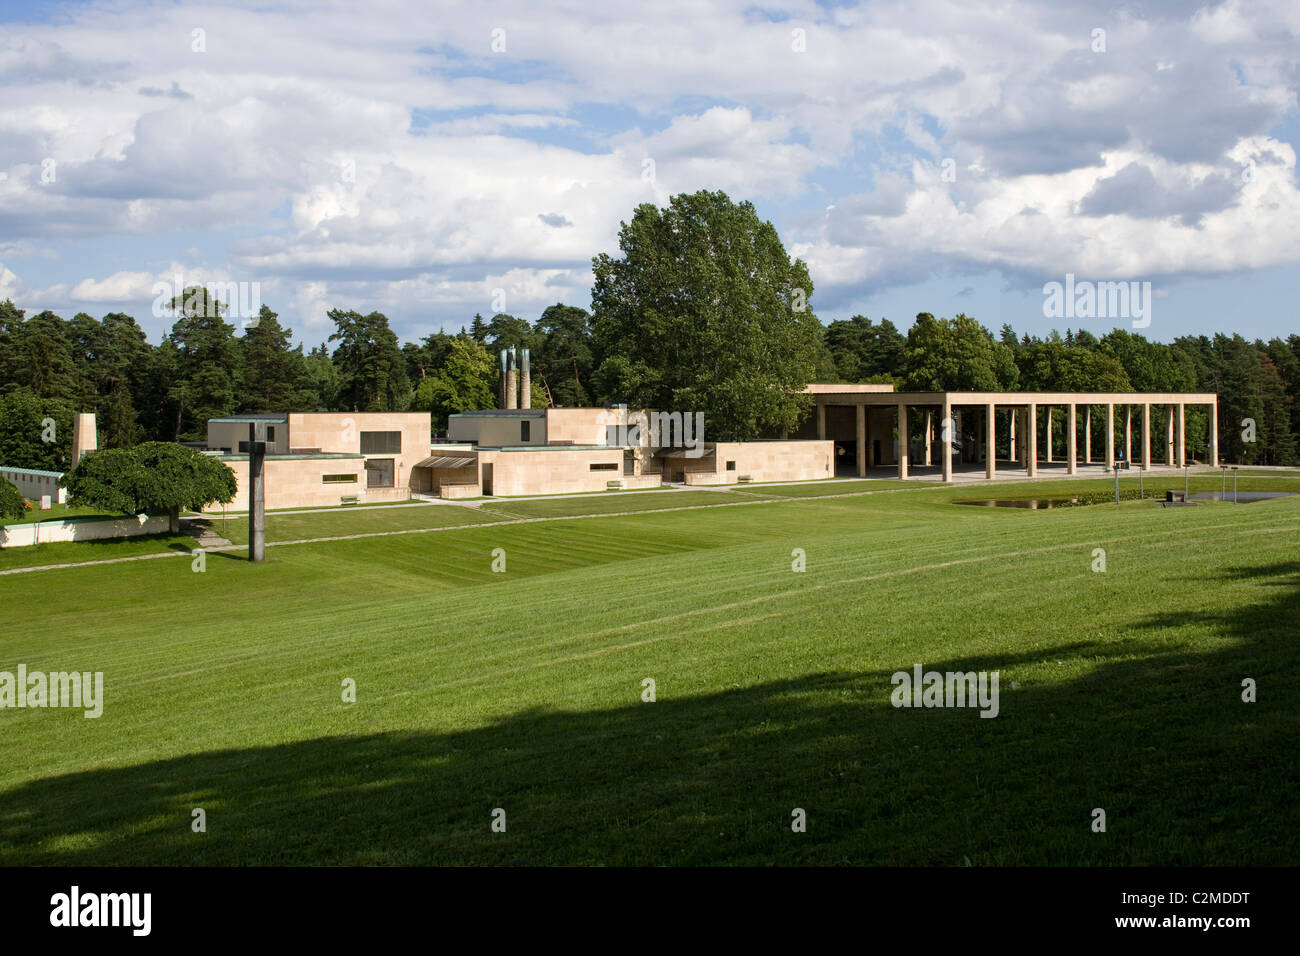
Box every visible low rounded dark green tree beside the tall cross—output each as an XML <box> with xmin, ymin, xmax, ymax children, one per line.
<box><xmin>60</xmin><ymin>441</ymin><xmax>238</xmax><ymax>533</ymax></box>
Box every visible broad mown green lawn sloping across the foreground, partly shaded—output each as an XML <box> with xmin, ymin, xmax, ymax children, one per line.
<box><xmin>0</xmin><ymin>475</ymin><xmax>1300</xmax><ymax>865</ymax></box>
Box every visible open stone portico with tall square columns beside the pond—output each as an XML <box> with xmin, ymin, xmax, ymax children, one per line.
<box><xmin>806</xmin><ymin>385</ymin><xmax>1218</xmax><ymax>481</ymax></box>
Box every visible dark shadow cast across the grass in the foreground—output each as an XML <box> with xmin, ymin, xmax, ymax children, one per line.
<box><xmin>0</xmin><ymin>562</ymin><xmax>1300</xmax><ymax>865</ymax></box>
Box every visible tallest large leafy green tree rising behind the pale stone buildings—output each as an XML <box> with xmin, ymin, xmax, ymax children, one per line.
<box><xmin>592</xmin><ymin>191</ymin><xmax>822</xmax><ymax>440</ymax></box>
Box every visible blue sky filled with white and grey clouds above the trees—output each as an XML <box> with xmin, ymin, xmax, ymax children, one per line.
<box><xmin>0</xmin><ymin>0</ymin><xmax>1300</xmax><ymax>345</ymax></box>
